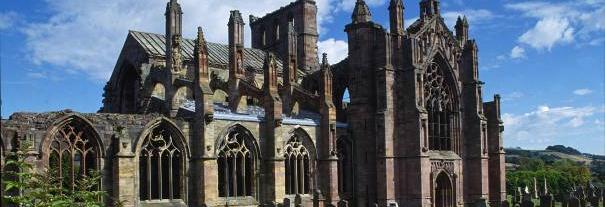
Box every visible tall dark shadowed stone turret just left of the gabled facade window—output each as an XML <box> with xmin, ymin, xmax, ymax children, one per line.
<box><xmin>345</xmin><ymin>0</ymin><xmax>397</xmax><ymax>206</ymax></box>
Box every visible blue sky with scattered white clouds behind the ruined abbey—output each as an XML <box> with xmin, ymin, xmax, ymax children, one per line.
<box><xmin>0</xmin><ymin>0</ymin><xmax>605</xmax><ymax>154</ymax></box>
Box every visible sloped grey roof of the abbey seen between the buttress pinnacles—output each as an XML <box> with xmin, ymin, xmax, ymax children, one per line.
<box><xmin>129</xmin><ymin>31</ymin><xmax>282</xmax><ymax>71</ymax></box>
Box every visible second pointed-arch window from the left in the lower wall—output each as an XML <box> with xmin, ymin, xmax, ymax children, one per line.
<box><xmin>139</xmin><ymin>122</ymin><xmax>185</xmax><ymax>200</ymax></box>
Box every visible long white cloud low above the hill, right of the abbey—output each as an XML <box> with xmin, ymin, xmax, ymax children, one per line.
<box><xmin>502</xmin><ymin>105</ymin><xmax>600</xmax><ymax>142</ymax></box>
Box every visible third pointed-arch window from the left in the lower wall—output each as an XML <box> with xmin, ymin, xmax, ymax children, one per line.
<box><xmin>217</xmin><ymin>127</ymin><xmax>257</xmax><ymax>197</ymax></box>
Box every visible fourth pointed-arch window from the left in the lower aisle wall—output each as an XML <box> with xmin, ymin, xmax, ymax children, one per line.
<box><xmin>284</xmin><ymin>135</ymin><xmax>312</xmax><ymax>195</ymax></box>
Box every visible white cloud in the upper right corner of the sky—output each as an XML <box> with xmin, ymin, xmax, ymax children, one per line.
<box><xmin>506</xmin><ymin>0</ymin><xmax>605</xmax><ymax>50</ymax></box>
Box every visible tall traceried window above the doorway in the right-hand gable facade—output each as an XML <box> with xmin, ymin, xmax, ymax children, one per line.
<box><xmin>424</xmin><ymin>63</ymin><xmax>454</xmax><ymax>150</ymax></box>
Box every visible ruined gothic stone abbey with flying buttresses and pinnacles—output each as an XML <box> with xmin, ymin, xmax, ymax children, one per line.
<box><xmin>1</xmin><ymin>0</ymin><xmax>507</xmax><ymax>207</ymax></box>
